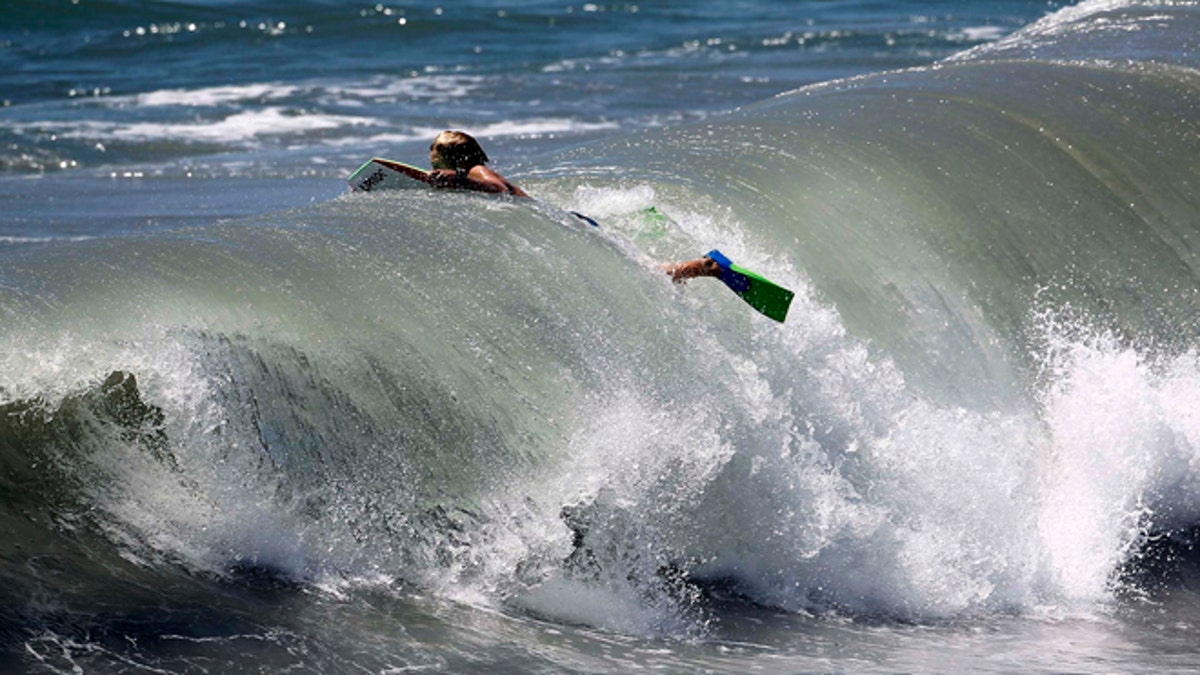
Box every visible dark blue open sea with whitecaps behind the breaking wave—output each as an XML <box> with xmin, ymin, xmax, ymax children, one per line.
<box><xmin>0</xmin><ymin>1</ymin><xmax>1052</xmax><ymax>192</ymax></box>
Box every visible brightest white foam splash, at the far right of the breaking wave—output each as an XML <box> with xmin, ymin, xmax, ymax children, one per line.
<box><xmin>1040</xmin><ymin>335</ymin><xmax>1200</xmax><ymax>599</ymax></box>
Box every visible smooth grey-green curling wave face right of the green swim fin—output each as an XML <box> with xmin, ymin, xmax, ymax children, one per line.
<box><xmin>573</xmin><ymin>4</ymin><xmax>1198</xmax><ymax>398</ymax></box>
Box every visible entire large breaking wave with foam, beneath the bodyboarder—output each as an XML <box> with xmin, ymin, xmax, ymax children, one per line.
<box><xmin>0</xmin><ymin>2</ymin><xmax>1200</xmax><ymax>648</ymax></box>
